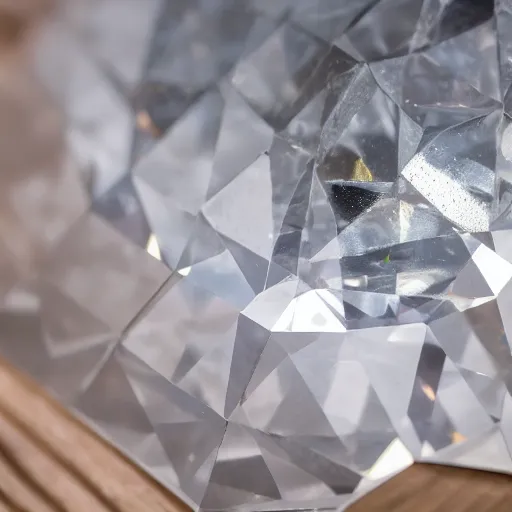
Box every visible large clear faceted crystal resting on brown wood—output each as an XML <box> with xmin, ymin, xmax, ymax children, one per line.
<box><xmin>0</xmin><ymin>0</ymin><xmax>512</xmax><ymax>511</ymax></box>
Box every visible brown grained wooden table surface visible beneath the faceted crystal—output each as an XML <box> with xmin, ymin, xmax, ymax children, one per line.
<box><xmin>0</xmin><ymin>362</ymin><xmax>504</xmax><ymax>512</ymax></box>
